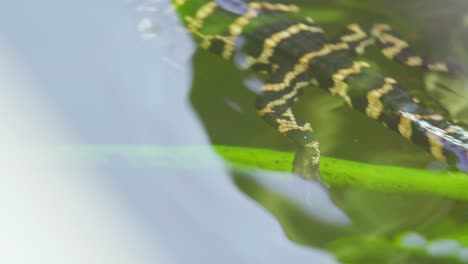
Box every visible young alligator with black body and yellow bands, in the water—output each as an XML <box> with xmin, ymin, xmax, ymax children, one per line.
<box><xmin>173</xmin><ymin>0</ymin><xmax>468</xmax><ymax>177</ymax></box>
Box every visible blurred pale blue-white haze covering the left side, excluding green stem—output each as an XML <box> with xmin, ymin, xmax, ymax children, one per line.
<box><xmin>0</xmin><ymin>0</ymin><xmax>346</xmax><ymax>264</ymax></box>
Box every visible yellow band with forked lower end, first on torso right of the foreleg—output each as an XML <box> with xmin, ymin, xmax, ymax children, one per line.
<box><xmin>329</xmin><ymin>61</ymin><xmax>370</xmax><ymax>107</ymax></box>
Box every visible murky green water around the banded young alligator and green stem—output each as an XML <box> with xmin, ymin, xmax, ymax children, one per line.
<box><xmin>185</xmin><ymin>0</ymin><xmax>468</xmax><ymax>263</ymax></box>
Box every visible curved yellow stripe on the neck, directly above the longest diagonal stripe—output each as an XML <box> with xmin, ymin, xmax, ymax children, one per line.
<box><xmin>245</xmin><ymin>23</ymin><xmax>323</xmax><ymax>67</ymax></box>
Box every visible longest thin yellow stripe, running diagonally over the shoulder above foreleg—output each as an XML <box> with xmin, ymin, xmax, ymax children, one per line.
<box><xmin>262</xmin><ymin>43</ymin><xmax>349</xmax><ymax>91</ymax></box>
